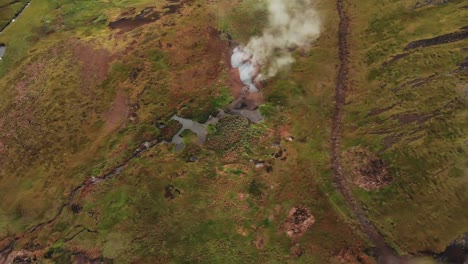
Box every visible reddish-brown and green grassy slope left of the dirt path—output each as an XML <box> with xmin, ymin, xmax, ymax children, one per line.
<box><xmin>0</xmin><ymin>0</ymin><xmax>366</xmax><ymax>263</ymax></box>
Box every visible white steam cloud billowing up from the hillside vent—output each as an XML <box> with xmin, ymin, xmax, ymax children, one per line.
<box><xmin>231</xmin><ymin>0</ymin><xmax>320</xmax><ymax>92</ymax></box>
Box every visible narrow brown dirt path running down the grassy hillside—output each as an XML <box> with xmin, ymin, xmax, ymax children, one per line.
<box><xmin>331</xmin><ymin>0</ymin><xmax>406</xmax><ymax>264</ymax></box>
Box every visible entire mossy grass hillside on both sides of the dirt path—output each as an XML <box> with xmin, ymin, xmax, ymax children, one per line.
<box><xmin>0</xmin><ymin>0</ymin><xmax>468</xmax><ymax>263</ymax></box>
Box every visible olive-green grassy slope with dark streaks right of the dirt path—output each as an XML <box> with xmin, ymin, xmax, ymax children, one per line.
<box><xmin>344</xmin><ymin>1</ymin><xmax>468</xmax><ymax>253</ymax></box>
